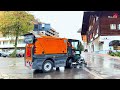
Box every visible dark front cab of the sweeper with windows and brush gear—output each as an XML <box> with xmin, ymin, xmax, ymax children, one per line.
<box><xmin>66</xmin><ymin>39</ymin><xmax>87</xmax><ymax>68</ymax></box>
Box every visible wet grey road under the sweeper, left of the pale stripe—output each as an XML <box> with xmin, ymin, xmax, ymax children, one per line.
<box><xmin>0</xmin><ymin>57</ymin><xmax>95</xmax><ymax>79</ymax></box>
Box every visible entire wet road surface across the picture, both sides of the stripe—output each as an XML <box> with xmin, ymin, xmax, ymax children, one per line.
<box><xmin>0</xmin><ymin>53</ymin><xmax>120</xmax><ymax>79</ymax></box>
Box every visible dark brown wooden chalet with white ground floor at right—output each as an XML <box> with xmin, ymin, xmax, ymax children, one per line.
<box><xmin>81</xmin><ymin>11</ymin><xmax>120</xmax><ymax>53</ymax></box>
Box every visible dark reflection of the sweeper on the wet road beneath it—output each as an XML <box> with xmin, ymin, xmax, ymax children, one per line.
<box><xmin>33</xmin><ymin>68</ymin><xmax>94</xmax><ymax>79</ymax></box>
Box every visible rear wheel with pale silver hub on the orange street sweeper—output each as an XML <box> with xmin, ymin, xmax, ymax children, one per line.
<box><xmin>42</xmin><ymin>60</ymin><xmax>53</xmax><ymax>73</ymax></box>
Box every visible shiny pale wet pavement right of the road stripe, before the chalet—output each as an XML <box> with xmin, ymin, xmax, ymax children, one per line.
<box><xmin>83</xmin><ymin>53</ymin><xmax>120</xmax><ymax>79</ymax></box>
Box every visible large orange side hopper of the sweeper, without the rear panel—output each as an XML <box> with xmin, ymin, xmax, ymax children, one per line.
<box><xmin>34</xmin><ymin>37</ymin><xmax>67</xmax><ymax>55</ymax></box>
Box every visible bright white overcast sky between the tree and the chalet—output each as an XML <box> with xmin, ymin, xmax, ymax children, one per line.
<box><xmin>30</xmin><ymin>11</ymin><xmax>83</xmax><ymax>40</ymax></box>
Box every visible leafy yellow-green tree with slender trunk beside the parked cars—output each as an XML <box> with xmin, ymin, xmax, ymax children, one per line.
<box><xmin>0</xmin><ymin>11</ymin><xmax>34</xmax><ymax>56</ymax></box>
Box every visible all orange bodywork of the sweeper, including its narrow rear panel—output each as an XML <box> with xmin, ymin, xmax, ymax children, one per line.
<box><xmin>25</xmin><ymin>36</ymin><xmax>68</xmax><ymax>62</ymax></box>
